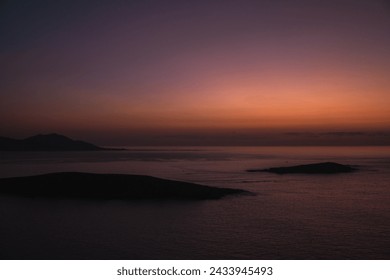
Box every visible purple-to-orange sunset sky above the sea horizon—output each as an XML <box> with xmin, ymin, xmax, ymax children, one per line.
<box><xmin>0</xmin><ymin>0</ymin><xmax>390</xmax><ymax>145</ymax></box>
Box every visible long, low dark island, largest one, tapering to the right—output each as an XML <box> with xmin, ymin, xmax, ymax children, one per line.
<box><xmin>0</xmin><ymin>172</ymin><xmax>249</xmax><ymax>200</ymax></box>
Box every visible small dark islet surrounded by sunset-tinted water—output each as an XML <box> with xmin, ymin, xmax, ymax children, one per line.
<box><xmin>247</xmin><ymin>162</ymin><xmax>357</xmax><ymax>174</ymax></box>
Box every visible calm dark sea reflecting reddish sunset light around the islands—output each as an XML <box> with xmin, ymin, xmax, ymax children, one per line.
<box><xmin>0</xmin><ymin>147</ymin><xmax>390</xmax><ymax>259</ymax></box>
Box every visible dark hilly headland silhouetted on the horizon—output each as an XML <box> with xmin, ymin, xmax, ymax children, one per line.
<box><xmin>0</xmin><ymin>133</ymin><xmax>124</xmax><ymax>151</ymax></box>
